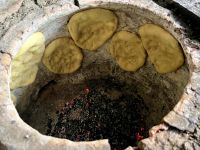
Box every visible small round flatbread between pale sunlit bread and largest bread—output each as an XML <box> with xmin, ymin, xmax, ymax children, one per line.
<box><xmin>42</xmin><ymin>37</ymin><xmax>83</xmax><ymax>74</ymax></box>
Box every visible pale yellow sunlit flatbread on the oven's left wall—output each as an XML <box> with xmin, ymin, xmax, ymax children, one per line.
<box><xmin>10</xmin><ymin>32</ymin><xmax>45</xmax><ymax>89</ymax></box>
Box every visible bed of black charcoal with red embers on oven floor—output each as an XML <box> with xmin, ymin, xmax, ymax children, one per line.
<box><xmin>46</xmin><ymin>77</ymin><xmax>147</xmax><ymax>150</ymax></box>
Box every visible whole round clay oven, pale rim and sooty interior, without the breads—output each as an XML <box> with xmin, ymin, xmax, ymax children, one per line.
<box><xmin>0</xmin><ymin>0</ymin><xmax>200</xmax><ymax>150</ymax></box>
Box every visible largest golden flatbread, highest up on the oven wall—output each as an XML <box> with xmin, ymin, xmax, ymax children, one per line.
<box><xmin>67</xmin><ymin>8</ymin><xmax>118</xmax><ymax>51</ymax></box>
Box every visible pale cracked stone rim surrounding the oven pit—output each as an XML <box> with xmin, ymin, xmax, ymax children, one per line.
<box><xmin>0</xmin><ymin>0</ymin><xmax>200</xmax><ymax>150</ymax></box>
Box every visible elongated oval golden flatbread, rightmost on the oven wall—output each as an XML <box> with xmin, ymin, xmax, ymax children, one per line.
<box><xmin>139</xmin><ymin>24</ymin><xmax>184</xmax><ymax>73</ymax></box>
